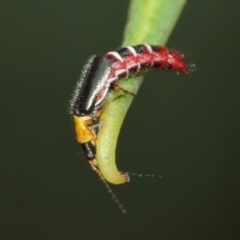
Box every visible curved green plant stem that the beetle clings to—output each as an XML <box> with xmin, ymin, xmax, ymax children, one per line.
<box><xmin>97</xmin><ymin>0</ymin><xmax>186</xmax><ymax>184</ymax></box>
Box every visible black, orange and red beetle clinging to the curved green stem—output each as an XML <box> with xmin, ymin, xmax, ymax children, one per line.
<box><xmin>70</xmin><ymin>44</ymin><xmax>189</xmax><ymax>212</ymax></box>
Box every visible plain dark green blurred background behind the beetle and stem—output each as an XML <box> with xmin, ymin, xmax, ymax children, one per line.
<box><xmin>0</xmin><ymin>0</ymin><xmax>240</xmax><ymax>240</ymax></box>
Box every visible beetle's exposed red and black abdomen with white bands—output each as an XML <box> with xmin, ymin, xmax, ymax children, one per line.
<box><xmin>96</xmin><ymin>44</ymin><xmax>188</xmax><ymax>105</ymax></box>
